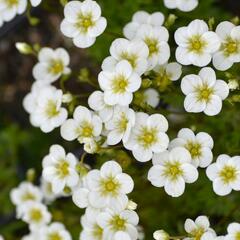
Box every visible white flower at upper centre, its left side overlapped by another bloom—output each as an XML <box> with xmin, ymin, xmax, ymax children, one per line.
<box><xmin>136</xmin><ymin>25</ymin><xmax>170</xmax><ymax>70</ymax></box>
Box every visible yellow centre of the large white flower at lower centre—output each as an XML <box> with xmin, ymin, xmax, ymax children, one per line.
<box><xmin>100</xmin><ymin>177</ymin><xmax>120</xmax><ymax>196</ymax></box>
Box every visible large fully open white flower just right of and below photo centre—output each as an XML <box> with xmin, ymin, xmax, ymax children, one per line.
<box><xmin>124</xmin><ymin>112</ymin><xmax>169</xmax><ymax>162</ymax></box>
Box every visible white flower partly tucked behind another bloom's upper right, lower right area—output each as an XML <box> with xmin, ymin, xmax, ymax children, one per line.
<box><xmin>169</xmin><ymin>128</ymin><xmax>214</xmax><ymax>168</ymax></box>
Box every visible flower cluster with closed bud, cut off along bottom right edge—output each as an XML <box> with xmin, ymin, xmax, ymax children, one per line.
<box><xmin>153</xmin><ymin>216</ymin><xmax>240</xmax><ymax>240</ymax></box>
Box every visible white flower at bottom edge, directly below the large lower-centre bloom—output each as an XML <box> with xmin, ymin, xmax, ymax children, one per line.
<box><xmin>97</xmin><ymin>209</ymin><xmax>139</xmax><ymax>240</ymax></box>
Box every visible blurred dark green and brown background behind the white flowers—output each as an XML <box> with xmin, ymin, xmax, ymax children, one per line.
<box><xmin>0</xmin><ymin>0</ymin><xmax>240</xmax><ymax>240</ymax></box>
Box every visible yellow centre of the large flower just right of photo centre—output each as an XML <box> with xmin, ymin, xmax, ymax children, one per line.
<box><xmin>137</xmin><ymin>127</ymin><xmax>158</xmax><ymax>148</ymax></box>
